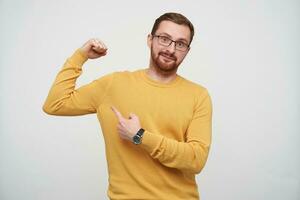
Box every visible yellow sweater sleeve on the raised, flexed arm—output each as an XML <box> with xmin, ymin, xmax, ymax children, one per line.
<box><xmin>43</xmin><ymin>49</ymin><xmax>113</xmax><ymax>116</ymax></box>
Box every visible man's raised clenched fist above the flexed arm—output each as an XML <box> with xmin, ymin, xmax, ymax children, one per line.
<box><xmin>80</xmin><ymin>39</ymin><xmax>107</xmax><ymax>59</ymax></box>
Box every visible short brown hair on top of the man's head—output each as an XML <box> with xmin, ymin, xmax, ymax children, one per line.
<box><xmin>151</xmin><ymin>12</ymin><xmax>194</xmax><ymax>44</ymax></box>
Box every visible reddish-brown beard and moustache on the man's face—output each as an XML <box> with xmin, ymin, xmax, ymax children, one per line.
<box><xmin>151</xmin><ymin>47</ymin><xmax>181</xmax><ymax>73</ymax></box>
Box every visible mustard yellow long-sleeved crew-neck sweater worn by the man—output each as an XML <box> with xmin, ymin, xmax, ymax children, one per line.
<box><xmin>43</xmin><ymin>49</ymin><xmax>212</xmax><ymax>200</ymax></box>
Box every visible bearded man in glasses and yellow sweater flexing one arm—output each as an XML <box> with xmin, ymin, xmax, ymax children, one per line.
<box><xmin>43</xmin><ymin>13</ymin><xmax>212</xmax><ymax>200</ymax></box>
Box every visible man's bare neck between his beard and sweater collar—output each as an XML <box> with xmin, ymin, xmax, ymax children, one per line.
<box><xmin>146</xmin><ymin>65</ymin><xmax>177</xmax><ymax>83</ymax></box>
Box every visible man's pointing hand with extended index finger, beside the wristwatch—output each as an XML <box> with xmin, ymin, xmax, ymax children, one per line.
<box><xmin>111</xmin><ymin>106</ymin><xmax>141</xmax><ymax>141</ymax></box>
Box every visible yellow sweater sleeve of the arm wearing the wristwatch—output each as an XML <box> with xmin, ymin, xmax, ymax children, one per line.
<box><xmin>141</xmin><ymin>90</ymin><xmax>212</xmax><ymax>174</ymax></box>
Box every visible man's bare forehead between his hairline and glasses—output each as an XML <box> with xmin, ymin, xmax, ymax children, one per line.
<box><xmin>156</xmin><ymin>21</ymin><xmax>191</xmax><ymax>42</ymax></box>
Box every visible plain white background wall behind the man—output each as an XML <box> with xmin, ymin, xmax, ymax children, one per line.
<box><xmin>0</xmin><ymin>0</ymin><xmax>300</xmax><ymax>200</ymax></box>
